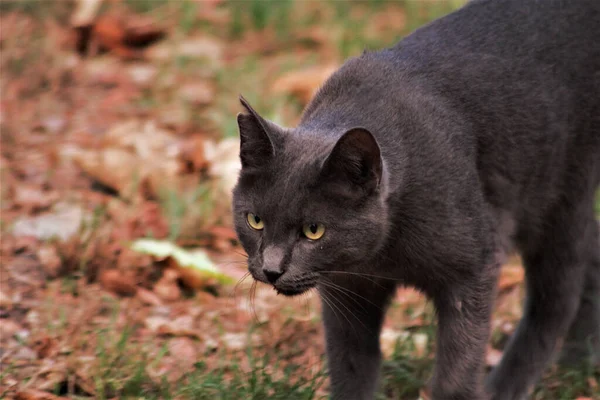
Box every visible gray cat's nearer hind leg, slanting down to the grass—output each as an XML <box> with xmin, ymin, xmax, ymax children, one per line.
<box><xmin>487</xmin><ymin>205</ymin><xmax>597</xmax><ymax>400</ymax></box>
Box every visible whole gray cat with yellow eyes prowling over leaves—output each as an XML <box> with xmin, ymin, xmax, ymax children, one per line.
<box><xmin>233</xmin><ymin>0</ymin><xmax>600</xmax><ymax>400</ymax></box>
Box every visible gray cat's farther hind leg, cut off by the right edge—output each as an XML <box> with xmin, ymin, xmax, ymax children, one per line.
<box><xmin>561</xmin><ymin>223</ymin><xmax>600</xmax><ymax>366</ymax></box>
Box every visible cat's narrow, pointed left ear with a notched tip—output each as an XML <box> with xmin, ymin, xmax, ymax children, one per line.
<box><xmin>237</xmin><ymin>96</ymin><xmax>275</xmax><ymax>168</ymax></box>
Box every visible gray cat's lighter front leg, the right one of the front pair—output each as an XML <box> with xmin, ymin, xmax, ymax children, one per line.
<box><xmin>431</xmin><ymin>273</ymin><xmax>495</xmax><ymax>400</ymax></box>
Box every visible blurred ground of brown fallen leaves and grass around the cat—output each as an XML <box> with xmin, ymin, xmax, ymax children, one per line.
<box><xmin>0</xmin><ymin>0</ymin><xmax>600</xmax><ymax>400</ymax></box>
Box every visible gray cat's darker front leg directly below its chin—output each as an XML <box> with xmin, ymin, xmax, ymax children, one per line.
<box><xmin>319</xmin><ymin>278</ymin><xmax>395</xmax><ymax>400</ymax></box>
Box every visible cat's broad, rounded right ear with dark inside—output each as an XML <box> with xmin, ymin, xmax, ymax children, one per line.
<box><xmin>322</xmin><ymin>128</ymin><xmax>383</xmax><ymax>193</ymax></box>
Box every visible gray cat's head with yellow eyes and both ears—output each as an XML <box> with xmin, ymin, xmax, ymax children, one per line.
<box><xmin>233</xmin><ymin>98</ymin><xmax>388</xmax><ymax>296</ymax></box>
